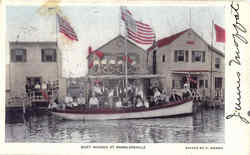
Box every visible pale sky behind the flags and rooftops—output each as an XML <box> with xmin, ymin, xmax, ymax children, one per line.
<box><xmin>6</xmin><ymin>4</ymin><xmax>225</xmax><ymax>77</ymax></box>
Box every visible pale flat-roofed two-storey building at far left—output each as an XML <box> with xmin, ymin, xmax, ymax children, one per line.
<box><xmin>6</xmin><ymin>42</ymin><xmax>66</xmax><ymax>103</ymax></box>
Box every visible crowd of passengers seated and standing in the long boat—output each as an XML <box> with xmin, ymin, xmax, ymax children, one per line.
<box><xmin>48</xmin><ymin>81</ymin><xmax>192</xmax><ymax>110</ymax></box>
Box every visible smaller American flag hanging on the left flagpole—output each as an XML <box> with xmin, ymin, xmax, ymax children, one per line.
<box><xmin>56</xmin><ymin>14</ymin><xmax>78</xmax><ymax>41</ymax></box>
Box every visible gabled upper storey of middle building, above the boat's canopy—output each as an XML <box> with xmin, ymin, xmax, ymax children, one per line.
<box><xmin>88</xmin><ymin>35</ymin><xmax>150</xmax><ymax>75</ymax></box>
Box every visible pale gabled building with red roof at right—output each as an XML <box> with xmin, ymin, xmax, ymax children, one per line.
<box><xmin>148</xmin><ymin>29</ymin><xmax>225</xmax><ymax>98</ymax></box>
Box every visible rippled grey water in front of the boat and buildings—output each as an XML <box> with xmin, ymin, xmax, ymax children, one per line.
<box><xmin>5</xmin><ymin>109</ymin><xmax>224</xmax><ymax>143</ymax></box>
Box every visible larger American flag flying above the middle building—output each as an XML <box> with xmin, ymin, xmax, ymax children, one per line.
<box><xmin>121</xmin><ymin>7</ymin><xmax>155</xmax><ymax>44</ymax></box>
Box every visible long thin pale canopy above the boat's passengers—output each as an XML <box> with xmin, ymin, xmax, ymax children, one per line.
<box><xmin>85</xmin><ymin>74</ymin><xmax>166</xmax><ymax>79</ymax></box>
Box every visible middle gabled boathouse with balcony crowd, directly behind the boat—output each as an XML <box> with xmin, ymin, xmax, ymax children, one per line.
<box><xmin>84</xmin><ymin>35</ymin><xmax>160</xmax><ymax>98</ymax></box>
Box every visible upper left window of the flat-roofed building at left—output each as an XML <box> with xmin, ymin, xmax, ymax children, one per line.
<box><xmin>11</xmin><ymin>48</ymin><xmax>27</xmax><ymax>62</ymax></box>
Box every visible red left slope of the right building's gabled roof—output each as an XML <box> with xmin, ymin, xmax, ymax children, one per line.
<box><xmin>148</xmin><ymin>29</ymin><xmax>190</xmax><ymax>51</ymax></box>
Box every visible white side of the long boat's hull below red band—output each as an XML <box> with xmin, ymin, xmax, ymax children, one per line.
<box><xmin>52</xmin><ymin>100</ymin><xmax>193</xmax><ymax>120</ymax></box>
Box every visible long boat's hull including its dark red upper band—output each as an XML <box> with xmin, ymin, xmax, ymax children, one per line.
<box><xmin>51</xmin><ymin>99</ymin><xmax>193</xmax><ymax>120</ymax></box>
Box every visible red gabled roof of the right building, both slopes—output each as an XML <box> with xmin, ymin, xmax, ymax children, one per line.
<box><xmin>147</xmin><ymin>28</ymin><xmax>225</xmax><ymax>57</ymax></box>
